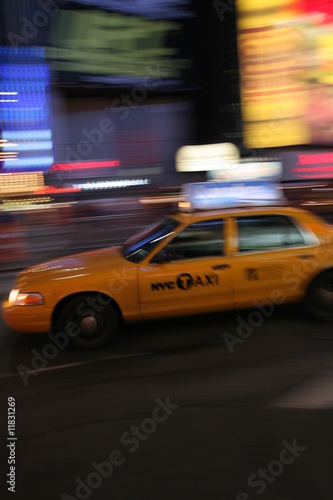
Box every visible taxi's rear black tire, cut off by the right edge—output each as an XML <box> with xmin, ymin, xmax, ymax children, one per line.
<box><xmin>306</xmin><ymin>270</ymin><xmax>333</xmax><ymax>321</ymax></box>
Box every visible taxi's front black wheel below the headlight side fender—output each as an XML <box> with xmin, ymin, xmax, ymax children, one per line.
<box><xmin>57</xmin><ymin>293</ymin><xmax>120</xmax><ymax>349</ymax></box>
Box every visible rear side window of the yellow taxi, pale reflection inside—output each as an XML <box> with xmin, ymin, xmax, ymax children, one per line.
<box><xmin>237</xmin><ymin>215</ymin><xmax>305</xmax><ymax>252</ymax></box>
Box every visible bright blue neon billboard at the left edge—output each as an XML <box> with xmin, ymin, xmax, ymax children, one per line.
<box><xmin>0</xmin><ymin>46</ymin><xmax>53</xmax><ymax>172</ymax></box>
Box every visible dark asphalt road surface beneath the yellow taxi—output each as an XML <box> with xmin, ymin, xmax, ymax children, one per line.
<box><xmin>0</xmin><ymin>300</ymin><xmax>333</xmax><ymax>500</ymax></box>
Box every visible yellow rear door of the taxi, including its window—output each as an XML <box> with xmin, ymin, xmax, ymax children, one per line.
<box><xmin>233</xmin><ymin>214</ymin><xmax>317</xmax><ymax>307</ymax></box>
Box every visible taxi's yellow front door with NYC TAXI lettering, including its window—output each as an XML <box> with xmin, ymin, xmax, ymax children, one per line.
<box><xmin>139</xmin><ymin>220</ymin><xmax>233</xmax><ymax>318</ymax></box>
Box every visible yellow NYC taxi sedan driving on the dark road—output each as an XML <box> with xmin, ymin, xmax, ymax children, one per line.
<box><xmin>2</xmin><ymin>182</ymin><xmax>333</xmax><ymax>349</ymax></box>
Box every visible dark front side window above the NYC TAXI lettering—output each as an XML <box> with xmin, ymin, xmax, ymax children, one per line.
<box><xmin>164</xmin><ymin>219</ymin><xmax>223</xmax><ymax>261</ymax></box>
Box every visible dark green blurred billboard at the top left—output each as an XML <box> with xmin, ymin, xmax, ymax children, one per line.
<box><xmin>47</xmin><ymin>0</ymin><xmax>197</xmax><ymax>92</ymax></box>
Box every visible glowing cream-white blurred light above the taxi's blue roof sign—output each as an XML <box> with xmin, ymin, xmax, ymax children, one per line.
<box><xmin>176</xmin><ymin>142</ymin><xmax>240</xmax><ymax>172</ymax></box>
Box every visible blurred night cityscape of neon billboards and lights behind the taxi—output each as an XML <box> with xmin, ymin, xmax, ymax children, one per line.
<box><xmin>0</xmin><ymin>0</ymin><xmax>333</xmax><ymax>276</ymax></box>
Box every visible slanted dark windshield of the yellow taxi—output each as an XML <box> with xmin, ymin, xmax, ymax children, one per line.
<box><xmin>123</xmin><ymin>218</ymin><xmax>180</xmax><ymax>263</ymax></box>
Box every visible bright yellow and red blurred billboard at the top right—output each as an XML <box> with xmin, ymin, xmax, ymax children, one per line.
<box><xmin>237</xmin><ymin>0</ymin><xmax>333</xmax><ymax>148</ymax></box>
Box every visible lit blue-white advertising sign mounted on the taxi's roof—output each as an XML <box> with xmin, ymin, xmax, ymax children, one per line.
<box><xmin>178</xmin><ymin>179</ymin><xmax>285</xmax><ymax>211</ymax></box>
